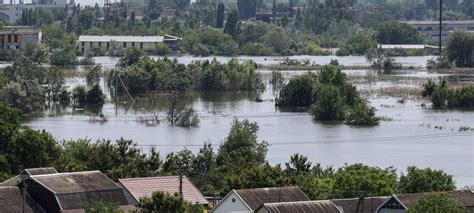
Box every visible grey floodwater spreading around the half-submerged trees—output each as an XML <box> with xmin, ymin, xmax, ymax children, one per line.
<box><xmin>23</xmin><ymin>57</ymin><xmax>474</xmax><ymax>187</ymax></box>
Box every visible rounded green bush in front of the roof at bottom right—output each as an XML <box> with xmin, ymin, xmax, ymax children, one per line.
<box><xmin>408</xmin><ymin>192</ymin><xmax>469</xmax><ymax>213</ymax></box>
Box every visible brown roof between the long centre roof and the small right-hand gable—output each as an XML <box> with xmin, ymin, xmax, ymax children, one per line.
<box><xmin>331</xmin><ymin>196</ymin><xmax>390</xmax><ymax>213</ymax></box>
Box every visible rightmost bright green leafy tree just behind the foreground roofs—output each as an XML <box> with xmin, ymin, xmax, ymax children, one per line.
<box><xmin>400</xmin><ymin>166</ymin><xmax>456</xmax><ymax>193</ymax></box>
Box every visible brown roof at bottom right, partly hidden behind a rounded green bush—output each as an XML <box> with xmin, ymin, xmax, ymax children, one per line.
<box><xmin>396</xmin><ymin>190</ymin><xmax>474</xmax><ymax>208</ymax></box>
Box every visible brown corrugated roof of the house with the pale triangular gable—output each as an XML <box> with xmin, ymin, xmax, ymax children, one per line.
<box><xmin>235</xmin><ymin>186</ymin><xmax>309</xmax><ymax>210</ymax></box>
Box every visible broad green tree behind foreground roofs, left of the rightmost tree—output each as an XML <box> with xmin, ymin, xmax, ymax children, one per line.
<box><xmin>333</xmin><ymin>164</ymin><xmax>398</xmax><ymax>198</ymax></box>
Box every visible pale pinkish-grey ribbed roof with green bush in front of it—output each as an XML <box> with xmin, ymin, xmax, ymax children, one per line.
<box><xmin>119</xmin><ymin>176</ymin><xmax>209</xmax><ymax>204</ymax></box>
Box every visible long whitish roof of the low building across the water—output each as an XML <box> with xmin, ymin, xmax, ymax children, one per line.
<box><xmin>78</xmin><ymin>35</ymin><xmax>165</xmax><ymax>43</ymax></box>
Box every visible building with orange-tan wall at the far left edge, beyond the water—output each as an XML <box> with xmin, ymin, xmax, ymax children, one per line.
<box><xmin>0</xmin><ymin>26</ymin><xmax>42</xmax><ymax>50</ymax></box>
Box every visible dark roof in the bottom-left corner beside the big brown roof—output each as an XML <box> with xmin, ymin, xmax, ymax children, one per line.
<box><xmin>0</xmin><ymin>186</ymin><xmax>39</xmax><ymax>213</ymax></box>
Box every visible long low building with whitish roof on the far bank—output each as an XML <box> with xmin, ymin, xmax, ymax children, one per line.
<box><xmin>78</xmin><ymin>35</ymin><xmax>181</xmax><ymax>53</ymax></box>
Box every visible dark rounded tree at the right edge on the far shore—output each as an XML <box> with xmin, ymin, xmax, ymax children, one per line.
<box><xmin>445</xmin><ymin>31</ymin><xmax>474</xmax><ymax>67</ymax></box>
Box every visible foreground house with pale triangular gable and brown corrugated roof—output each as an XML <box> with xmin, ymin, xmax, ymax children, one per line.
<box><xmin>212</xmin><ymin>186</ymin><xmax>309</xmax><ymax>213</ymax></box>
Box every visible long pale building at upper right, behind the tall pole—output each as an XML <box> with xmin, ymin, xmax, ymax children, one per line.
<box><xmin>404</xmin><ymin>20</ymin><xmax>474</xmax><ymax>40</ymax></box>
